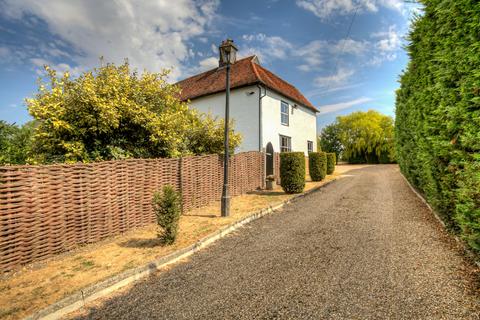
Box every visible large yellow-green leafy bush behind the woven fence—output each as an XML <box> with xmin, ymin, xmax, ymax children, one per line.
<box><xmin>26</xmin><ymin>62</ymin><xmax>241</xmax><ymax>163</ymax></box>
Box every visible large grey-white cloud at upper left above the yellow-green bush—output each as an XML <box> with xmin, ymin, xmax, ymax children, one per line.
<box><xmin>0</xmin><ymin>0</ymin><xmax>219</xmax><ymax>78</ymax></box>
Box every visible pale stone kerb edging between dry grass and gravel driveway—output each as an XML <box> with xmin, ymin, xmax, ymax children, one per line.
<box><xmin>24</xmin><ymin>179</ymin><xmax>341</xmax><ymax>320</ymax></box>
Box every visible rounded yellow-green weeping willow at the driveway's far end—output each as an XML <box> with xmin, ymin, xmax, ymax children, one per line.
<box><xmin>321</xmin><ymin>110</ymin><xmax>395</xmax><ymax>163</ymax></box>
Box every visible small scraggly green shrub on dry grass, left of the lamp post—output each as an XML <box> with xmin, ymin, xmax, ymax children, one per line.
<box><xmin>153</xmin><ymin>185</ymin><xmax>182</xmax><ymax>244</ymax></box>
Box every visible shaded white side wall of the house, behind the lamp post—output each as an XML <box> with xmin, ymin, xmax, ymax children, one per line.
<box><xmin>190</xmin><ymin>86</ymin><xmax>259</xmax><ymax>152</ymax></box>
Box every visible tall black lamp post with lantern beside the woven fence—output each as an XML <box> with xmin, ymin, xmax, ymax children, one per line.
<box><xmin>218</xmin><ymin>39</ymin><xmax>237</xmax><ymax>217</ymax></box>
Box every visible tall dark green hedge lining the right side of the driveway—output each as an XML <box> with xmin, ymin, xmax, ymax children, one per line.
<box><xmin>395</xmin><ymin>0</ymin><xmax>480</xmax><ymax>250</ymax></box>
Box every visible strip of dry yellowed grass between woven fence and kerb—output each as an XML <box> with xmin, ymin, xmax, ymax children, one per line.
<box><xmin>0</xmin><ymin>166</ymin><xmax>351</xmax><ymax>319</ymax></box>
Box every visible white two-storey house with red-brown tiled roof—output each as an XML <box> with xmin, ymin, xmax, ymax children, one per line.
<box><xmin>177</xmin><ymin>56</ymin><xmax>318</xmax><ymax>153</ymax></box>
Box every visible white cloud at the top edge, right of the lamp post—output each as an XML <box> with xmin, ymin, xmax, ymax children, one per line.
<box><xmin>296</xmin><ymin>0</ymin><xmax>404</xmax><ymax>20</ymax></box>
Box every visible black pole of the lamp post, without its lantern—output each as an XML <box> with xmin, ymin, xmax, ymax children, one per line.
<box><xmin>222</xmin><ymin>58</ymin><xmax>230</xmax><ymax>217</ymax></box>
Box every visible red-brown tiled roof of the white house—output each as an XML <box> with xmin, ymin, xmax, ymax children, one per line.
<box><xmin>177</xmin><ymin>56</ymin><xmax>318</xmax><ymax>112</ymax></box>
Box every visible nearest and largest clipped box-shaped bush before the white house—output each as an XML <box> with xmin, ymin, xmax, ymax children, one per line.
<box><xmin>280</xmin><ymin>152</ymin><xmax>305</xmax><ymax>193</ymax></box>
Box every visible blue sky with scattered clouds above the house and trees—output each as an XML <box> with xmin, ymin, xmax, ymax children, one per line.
<box><xmin>0</xmin><ymin>0</ymin><xmax>415</xmax><ymax>130</ymax></box>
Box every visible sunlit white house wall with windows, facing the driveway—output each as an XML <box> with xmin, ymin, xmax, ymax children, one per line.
<box><xmin>262</xmin><ymin>89</ymin><xmax>317</xmax><ymax>154</ymax></box>
